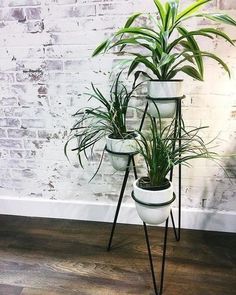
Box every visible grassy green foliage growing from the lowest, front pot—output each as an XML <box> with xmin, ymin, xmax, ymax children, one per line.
<box><xmin>137</xmin><ymin>115</ymin><xmax>217</xmax><ymax>188</ymax></box>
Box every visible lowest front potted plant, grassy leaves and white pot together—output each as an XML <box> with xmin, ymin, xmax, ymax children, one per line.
<box><xmin>132</xmin><ymin>115</ymin><xmax>216</xmax><ymax>225</ymax></box>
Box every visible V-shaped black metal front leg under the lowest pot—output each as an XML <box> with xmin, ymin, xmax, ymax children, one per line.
<box><xmin>143</xmin><ymin>218</ymin><xmax>169</xmax><ymax>295</ymax></box>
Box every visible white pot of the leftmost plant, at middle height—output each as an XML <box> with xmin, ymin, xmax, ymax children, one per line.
<box><xmin>106</xmin><ymin>136</ymin><xmax>137</xmax><ymax>171</ymax></box>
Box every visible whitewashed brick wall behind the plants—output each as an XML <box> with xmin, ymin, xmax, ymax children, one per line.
<box><xmin>0</xmin><ymin>0</ymin><xmax>236</xmax><ymax>211</ymax></box>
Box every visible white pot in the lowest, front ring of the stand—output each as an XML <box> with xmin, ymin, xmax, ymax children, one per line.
<box><xmin>133</xmin><ymin>179</ymin><xmax>175</xmax><ymax>225</ymax></box>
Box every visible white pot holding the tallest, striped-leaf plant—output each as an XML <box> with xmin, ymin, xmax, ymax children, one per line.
<box><xmin>147</xmin><ymin>80</ymin><xmax>183</xmax><ymax>118</ymax></box>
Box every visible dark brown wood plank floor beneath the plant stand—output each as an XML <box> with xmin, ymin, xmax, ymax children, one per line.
<box><xmin>0</xmin><ymin>216</ymin><xmax>236</xmax><ymax>295</ymax></box>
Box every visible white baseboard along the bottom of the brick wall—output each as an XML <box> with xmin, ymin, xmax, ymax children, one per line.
<box><xmin>0</xmin><ymin>197</ymin><xmax>236</xmax><ymax>232</ymax></box>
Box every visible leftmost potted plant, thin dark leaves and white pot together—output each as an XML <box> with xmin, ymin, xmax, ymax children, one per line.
<box><xmin>65</xmin><ymin>72</ymin><xmax>138</xmax><ymax>175</ymax></box>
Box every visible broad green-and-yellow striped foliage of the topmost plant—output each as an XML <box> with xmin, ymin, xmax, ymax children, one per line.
<box><xmin>93</xmin><ymin>0</ymin><xmax>236</xmax><ymax>81</ymax></box>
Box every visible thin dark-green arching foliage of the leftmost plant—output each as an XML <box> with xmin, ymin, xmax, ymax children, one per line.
<box><xmin>64</xmin><ymin>72</ymin><xmax>139</xmax><ymax>168</ymax></box>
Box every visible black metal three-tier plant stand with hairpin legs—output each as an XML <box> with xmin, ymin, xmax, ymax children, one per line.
<box><xmin>105</xmin><ymin>96</ymin><xmax>184</xmax><ymax>295</ymax></box>
